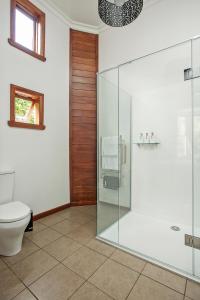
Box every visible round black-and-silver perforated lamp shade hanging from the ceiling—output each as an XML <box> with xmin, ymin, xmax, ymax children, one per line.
<box><xmin>98</xmin><ymin>0</ymin><xmax>143</xmax><ymax>27</ymax></box>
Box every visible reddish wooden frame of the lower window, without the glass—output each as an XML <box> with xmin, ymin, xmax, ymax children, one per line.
<box><xmin>8</xmin><ymin>84</ymin><xmax>46</xmax><ymax>130</ymax></box>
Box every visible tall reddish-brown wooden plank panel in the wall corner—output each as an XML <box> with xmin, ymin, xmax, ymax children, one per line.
<box><xmin>70</xmin><ymin>30</ymin><xmax>98</xmax><ymax>205</ymax></box>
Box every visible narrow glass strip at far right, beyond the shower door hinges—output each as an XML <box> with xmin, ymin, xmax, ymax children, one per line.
<box><xmin>192</xmin><ymin>39</ymin><xmax>200</xmax><ymax>277</ymax></box>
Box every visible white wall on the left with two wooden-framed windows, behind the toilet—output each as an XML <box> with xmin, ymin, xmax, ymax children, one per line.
<box><xmin>0</xmin><ymin>0</ymin><xmax>69</xmax><ymax>214</ymax></box>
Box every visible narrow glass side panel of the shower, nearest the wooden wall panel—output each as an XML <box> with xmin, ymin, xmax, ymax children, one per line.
<box><xmin>97</xmin><ymin>70</ymin><xmax>119</xmax><ymax>243</ymax></box>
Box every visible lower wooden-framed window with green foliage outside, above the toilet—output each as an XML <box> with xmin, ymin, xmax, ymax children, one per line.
<box><xmin>8</xmin><ymin>84</ymin><xmax>45</xmax><ymax>130</ymax></box>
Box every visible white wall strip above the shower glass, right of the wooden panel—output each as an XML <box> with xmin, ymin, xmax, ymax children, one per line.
<box><xmin>99</xmin><ymin>0</ymin><xmax>200</xmax><ymax>70</ymax></box>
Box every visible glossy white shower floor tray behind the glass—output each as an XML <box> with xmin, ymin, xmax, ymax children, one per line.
<box><xmin>99</xmin><ymin>211</ymin><xmax>193</xmax><ymax>274</ymax></box>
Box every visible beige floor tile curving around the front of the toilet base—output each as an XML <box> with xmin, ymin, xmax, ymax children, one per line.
<box><xmin>3</xmin><ymin>238</ymin><xmax>39</xmax><ymax>265</ymax></box>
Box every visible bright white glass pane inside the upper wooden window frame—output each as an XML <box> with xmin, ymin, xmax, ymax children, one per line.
<box><xmin>15</xmin><ymin>9</ymin><xmax>34</xmax><ymax>50</ymax></box>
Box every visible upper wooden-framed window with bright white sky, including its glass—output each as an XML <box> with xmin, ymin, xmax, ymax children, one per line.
<box><xmin>8</xmin><ymin>0</ymin><xmax>46</xmax><ymax>61</ymax></box>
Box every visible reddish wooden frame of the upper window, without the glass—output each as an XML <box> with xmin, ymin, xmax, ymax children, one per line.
<box><xmin>8</xmin><ymin>0</ymin><xmax>46</xmax><ymax>62</ymax></box>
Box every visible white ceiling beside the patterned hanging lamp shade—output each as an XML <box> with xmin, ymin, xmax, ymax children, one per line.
<box><xmin>46</xmin><ymin>0</ymin><xmax>152</xmax><ymax>27</ymax></box>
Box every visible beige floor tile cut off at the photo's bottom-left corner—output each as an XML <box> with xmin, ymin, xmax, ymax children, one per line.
<box><xmin>0</xmin><ymin>269</ymin><xmax>25</xmax><ymax>300</ymax></box>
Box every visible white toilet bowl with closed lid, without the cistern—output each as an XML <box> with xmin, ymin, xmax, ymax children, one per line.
<box><xmin>0</xmin><ymin>202</ymin><xmax>31</xmax><ymax>256</ymax></box>
